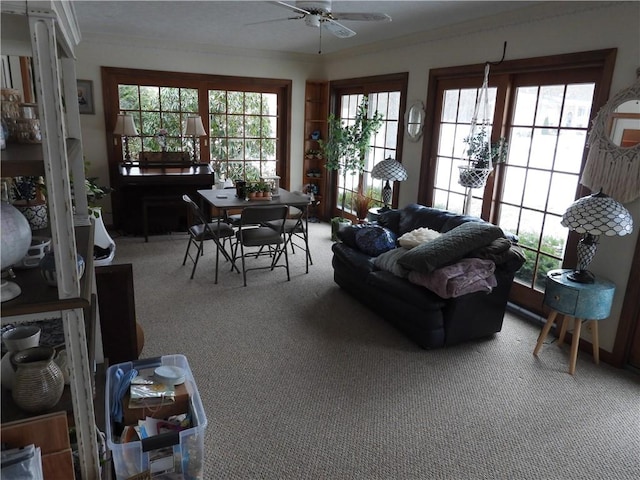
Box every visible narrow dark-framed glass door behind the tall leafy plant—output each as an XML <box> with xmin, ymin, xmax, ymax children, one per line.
<box><xmin>331</xmin><ymin>74</ymin><xmax>407</xmax><ymax>219</ymax></box>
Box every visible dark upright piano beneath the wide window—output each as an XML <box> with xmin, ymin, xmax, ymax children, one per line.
<box><xmin>112</xmin><ymin>152</ymin><xmax>215</xmax><ymax>236</ymax></box>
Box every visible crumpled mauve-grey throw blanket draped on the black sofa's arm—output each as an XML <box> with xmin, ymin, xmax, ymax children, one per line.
<box><xmin>408</xmin><ymin>258</ymin><xmax>498</xmax><ymax>298</ymax></box>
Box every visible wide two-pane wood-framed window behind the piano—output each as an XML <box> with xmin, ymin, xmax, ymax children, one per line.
<box><xmin>102</xmin><ymin>67</ymin><xmax>291</xmax><ymax>185</ymax></box>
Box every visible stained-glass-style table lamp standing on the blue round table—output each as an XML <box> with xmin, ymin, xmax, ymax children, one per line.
<box><xmin>560</xmin><ymin>190</ymin><xmax>633</xmax><ymax>283</ymax></box>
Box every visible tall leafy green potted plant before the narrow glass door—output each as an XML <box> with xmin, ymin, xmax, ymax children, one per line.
<box><xmin>318</xmin><ymin>96</ymin><xmax>382</xmax><ymax>240</ymax></box>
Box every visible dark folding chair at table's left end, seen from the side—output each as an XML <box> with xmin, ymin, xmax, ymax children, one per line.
<box><xmin>182</xmin><ymin>195</ymin><xmax>239</xmax><ymax>283</ymax></box>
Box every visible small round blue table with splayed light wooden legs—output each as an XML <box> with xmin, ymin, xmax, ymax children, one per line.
<box><xmin>533</xmin><ymin>269</ymin><xmax>616</xmax><ymax>375</ymax></box>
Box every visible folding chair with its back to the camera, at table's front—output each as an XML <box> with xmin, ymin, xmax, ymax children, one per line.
<box><xmin>233</xmin><ymin>205</ymin><xmax>291</xmax><ymax>287</ymax></box>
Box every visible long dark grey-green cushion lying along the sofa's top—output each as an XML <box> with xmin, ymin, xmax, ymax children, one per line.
<box><xmin>399</xmin><ymin>222</ymin><xmax>504</xmax><ymax>273</ymax></box>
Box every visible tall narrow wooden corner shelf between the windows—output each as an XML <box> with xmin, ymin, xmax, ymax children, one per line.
<box><xmin>302</xmin><ymin>81</ymin><xmax>329</xmax><ymax>220</ymax></box>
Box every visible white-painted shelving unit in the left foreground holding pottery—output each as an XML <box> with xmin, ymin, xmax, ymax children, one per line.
<box><xmin>0</xmin><ymin>0</ymin><xmax>100</xmax><ymax>480</ymax></box>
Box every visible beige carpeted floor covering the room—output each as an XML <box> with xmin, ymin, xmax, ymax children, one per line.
<box><xmin>114</xmin><ymin>224</ymin><xmax>640</xmax><ymax>480</ymax></box>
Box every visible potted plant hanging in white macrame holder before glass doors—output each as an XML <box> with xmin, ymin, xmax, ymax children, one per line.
<box><xmin>458</xmin><ymin>63</ymin><xmax>493</xmax><ymax>188</ymax></box>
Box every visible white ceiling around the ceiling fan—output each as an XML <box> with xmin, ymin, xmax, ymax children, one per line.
<box><xmin>74</xmin><ymin>0</ymin><xmax>535</xmax><ymax>54</ymax></box>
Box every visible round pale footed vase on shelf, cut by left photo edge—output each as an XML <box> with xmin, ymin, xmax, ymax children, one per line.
<box><xmin>0</xmin><ymin>202</ymin><xmax>31</xmax><ymax>302</ymax></box>
